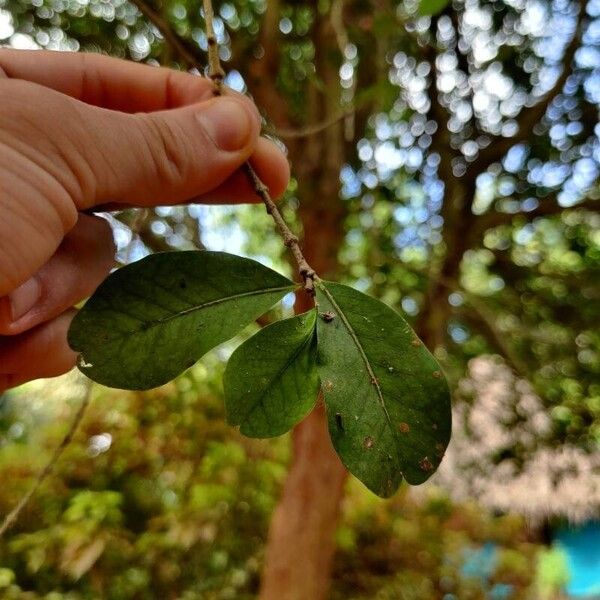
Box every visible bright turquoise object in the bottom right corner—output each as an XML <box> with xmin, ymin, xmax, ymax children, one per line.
<box><xmin>556</xmin><ymin>521</ymin><xmax>600</xmax><ymax>600</ymax></box>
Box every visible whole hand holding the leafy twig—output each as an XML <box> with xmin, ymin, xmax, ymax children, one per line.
<box><xmin>0</xmin><ymin>49</ymin><xmax>289</xmax><ymax>393</ymax></box>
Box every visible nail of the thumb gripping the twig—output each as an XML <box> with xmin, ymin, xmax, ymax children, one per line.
<box><xmin>196</xmin><ymin>98</ymin><xmax>252</xmax><ymax>152</ymax></box>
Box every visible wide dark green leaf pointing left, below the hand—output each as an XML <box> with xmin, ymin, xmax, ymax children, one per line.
<box><xmin>69</xmin><ymin>251</ymin><xmax>294</xmax><ymax>390</ymax></box>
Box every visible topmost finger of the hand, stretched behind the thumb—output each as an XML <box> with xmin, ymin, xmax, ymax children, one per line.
<box><xmin>0</xmin><ymin>48</ymin><xmax>218</xmax><ymax>113</ymax></box>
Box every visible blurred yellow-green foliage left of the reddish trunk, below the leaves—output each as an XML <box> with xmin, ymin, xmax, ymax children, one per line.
<box><xmin>0</xmin><ymin>366</ymin><xmax>287</xmax><ymax>599</ymax></box>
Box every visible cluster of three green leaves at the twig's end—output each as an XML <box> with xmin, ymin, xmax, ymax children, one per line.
<box><xmin>69</xmin><ymin>251</ymin><xmax>451</xmax><ymax>497</ymax></box>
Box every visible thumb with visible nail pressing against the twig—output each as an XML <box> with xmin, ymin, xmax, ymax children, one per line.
<box><xmin>75</xmin><ymin>96</ymin><xmax>260</xmax><ymax>209</ymax></box>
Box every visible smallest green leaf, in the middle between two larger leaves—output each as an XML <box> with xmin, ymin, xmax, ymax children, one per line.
<box><xmin>224</xmin><ymin>310</ymin><xmax>319</xmax><ymax>437</ymax></box>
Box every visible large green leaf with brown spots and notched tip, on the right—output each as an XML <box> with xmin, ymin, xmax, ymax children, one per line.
<box><xmin>317</xmin><ymin>282</ymin><xmax>451</xmax><ymax>497</ymax></box>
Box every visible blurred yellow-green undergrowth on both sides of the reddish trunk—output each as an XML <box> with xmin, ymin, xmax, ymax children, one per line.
<box><xmin>0</xmin><ymin>372</ymin><xmax>568</xmax><ymax>600</ymax></box>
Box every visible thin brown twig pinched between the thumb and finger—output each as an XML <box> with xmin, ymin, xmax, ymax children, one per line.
<box><xmin>203</xmin><ymin>0</ymin><xmax>318</xmax><ymax>296</ymax></box>
